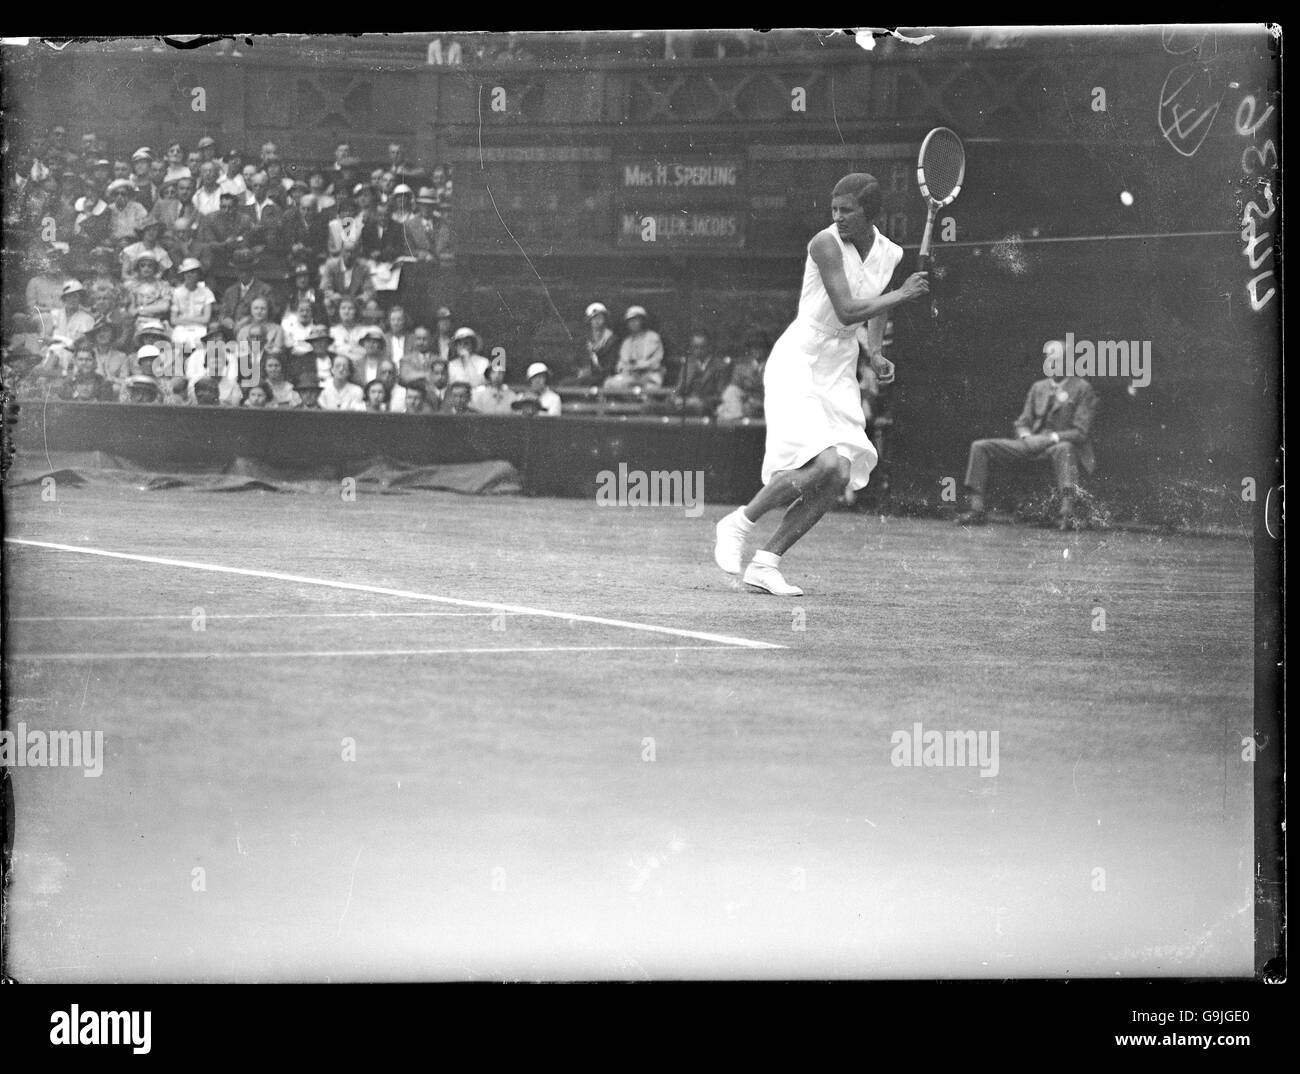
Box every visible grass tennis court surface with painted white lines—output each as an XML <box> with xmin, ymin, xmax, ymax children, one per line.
<box><xmin>4</xmin><ymin>484</ymin><xmax>1253</xmax><ymax>980</ymax></box>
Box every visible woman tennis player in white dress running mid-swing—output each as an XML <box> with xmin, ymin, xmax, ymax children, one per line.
<box><xmin>714</xmin><ymin>172</ymin><xmax>930</xmax><ymax>597</ymax></box>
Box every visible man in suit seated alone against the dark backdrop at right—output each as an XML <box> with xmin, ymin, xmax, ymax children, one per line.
<box><xmin>957</xmin><ymin>339</ymin><xmax>1097</xmax><ymax>529</ymax></box>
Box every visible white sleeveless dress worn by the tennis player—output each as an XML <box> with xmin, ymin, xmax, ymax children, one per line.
<box><xmin>763</xmin><ymin>224</ymin><xmax>902</xmax><ymax>489</ymax></box>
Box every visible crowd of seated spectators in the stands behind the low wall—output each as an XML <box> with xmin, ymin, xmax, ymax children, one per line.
<box><xmin>4</xmin><ymin>127</ymin><xmax>770</xmax><ymax>420</ymax></box>
